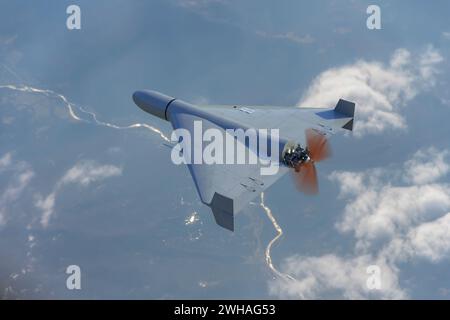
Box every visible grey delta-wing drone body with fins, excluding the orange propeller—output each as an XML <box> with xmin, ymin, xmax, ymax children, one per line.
<box><xmin>133</xmin><ymin>90</ymin><xmax>355</xmax><ymax>231</ymax></box>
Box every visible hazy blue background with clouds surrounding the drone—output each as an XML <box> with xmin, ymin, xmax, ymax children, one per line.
<box><xmin>0</xmin><ymin>0</ymin><xmax>450</xmax><ymax>299</ymax></box>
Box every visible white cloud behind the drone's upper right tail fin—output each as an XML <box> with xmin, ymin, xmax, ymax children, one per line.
<box><xmin>298</xmin><ymin>45</ymin><xmax>443</xmax><ymax>137</ymax></box>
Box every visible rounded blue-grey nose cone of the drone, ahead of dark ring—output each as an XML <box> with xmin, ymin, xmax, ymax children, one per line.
<box><xmin>133</xmin><ymin>90</ymin><xmax>174</xmax><ymax>120</ymax></box>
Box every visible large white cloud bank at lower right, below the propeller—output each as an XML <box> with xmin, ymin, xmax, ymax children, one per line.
<box><xmin>269</xmin><ymin>147</ymin><xmax>450</xmax><ymax>299</ymax></box>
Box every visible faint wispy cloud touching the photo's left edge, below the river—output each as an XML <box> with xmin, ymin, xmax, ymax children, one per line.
<box><xmin>0</xmin><ymin>152</ymin><xmax>34</xmax><ymax>226</ymax></box>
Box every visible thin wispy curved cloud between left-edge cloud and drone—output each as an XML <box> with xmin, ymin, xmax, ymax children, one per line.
<box><xmin>35</xmin><ymin>161</ymin><xmax>122</xmax><ymax>228</ymax></box>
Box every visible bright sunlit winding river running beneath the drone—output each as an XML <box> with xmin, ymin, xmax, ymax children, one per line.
<box><xmin>0</xmin><ymin>84</ymin><xmax>288</xmax><ymax>280</ymax></box>
